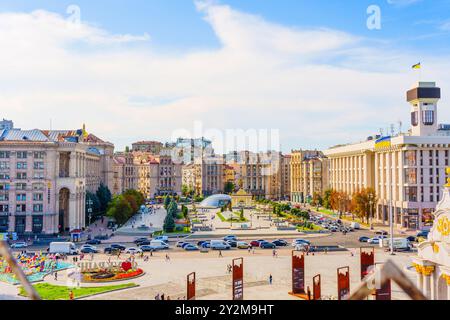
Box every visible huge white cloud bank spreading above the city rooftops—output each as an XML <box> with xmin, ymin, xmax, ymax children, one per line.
<box><xmin>0</xmin><ymin>2</ymin><xmax>450</xmax><ymax>152</ymax></box>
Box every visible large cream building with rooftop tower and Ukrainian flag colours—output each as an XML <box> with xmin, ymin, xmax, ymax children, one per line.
<box><xmin>324</xmin><ymin>82</ymin><xmax>450</xmax><ymax>229</ymax></box>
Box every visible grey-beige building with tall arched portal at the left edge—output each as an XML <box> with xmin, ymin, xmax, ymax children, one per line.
<box><xmin>0</xmin><ymin>128</ymin><xmax>114</xmax><ymax>235</ymax></box>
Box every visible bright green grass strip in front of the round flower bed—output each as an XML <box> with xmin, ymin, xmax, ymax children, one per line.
<box><xmin>19</xmin><ymin>283</ymin><xmax>136</xmax><ymax>300</ymax></box>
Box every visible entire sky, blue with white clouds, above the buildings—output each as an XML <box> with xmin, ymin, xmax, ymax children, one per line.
<box><xmin>0</xmin><ymin>0</ymin><xmax>450</xmax><ymax>151</ymax></box>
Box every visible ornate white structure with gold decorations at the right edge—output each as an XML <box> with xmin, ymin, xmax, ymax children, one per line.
<box><xmin>413</xmin><ymin>170</ymin><xmax>450</xmax><ymax>300</ymax></box>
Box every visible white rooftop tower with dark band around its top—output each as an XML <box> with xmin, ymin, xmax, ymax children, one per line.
<box><xmin>407</xmin><ymin>82</ymin><xmax>441</xmax><ymax>136</ymax></box>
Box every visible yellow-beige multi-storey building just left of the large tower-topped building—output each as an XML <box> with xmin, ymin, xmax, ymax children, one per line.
<box><xmin>290</xmin><ymin>150</ymin><xmax>328</xmax><ymax>203</ymax></box>
